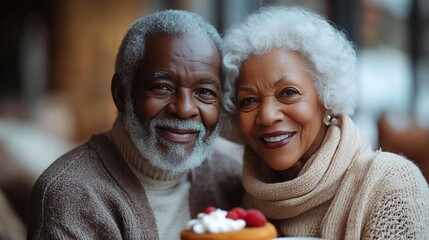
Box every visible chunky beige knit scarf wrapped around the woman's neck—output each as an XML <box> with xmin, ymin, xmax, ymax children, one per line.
<box><xmin>243</xmin><ymin>116</ymin><xmax>363</xmax><ymax>219</ymax></box>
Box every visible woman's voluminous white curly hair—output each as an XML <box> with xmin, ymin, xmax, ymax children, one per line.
<box><xmin>223</xmin><ymin>6</ymin><xmax>358</xmax><ymax>115</ymax></box>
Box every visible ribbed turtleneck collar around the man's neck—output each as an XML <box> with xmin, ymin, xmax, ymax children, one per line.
<box><xmin>108</xmin><ymin>117</ymin><xmax>188</xmax><ymax>181</ymax></box>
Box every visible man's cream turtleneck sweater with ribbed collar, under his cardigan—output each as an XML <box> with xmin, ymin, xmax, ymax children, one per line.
<box><xmin>109</xmin><ymin>119</ymin><xmax>191</xmax><ymax>239</ymax></box>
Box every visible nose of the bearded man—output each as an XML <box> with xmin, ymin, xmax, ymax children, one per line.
<box><xmin>167</xmin><ymin>91</ymin><xmax>198</xmax><ymax>119</ymax></box>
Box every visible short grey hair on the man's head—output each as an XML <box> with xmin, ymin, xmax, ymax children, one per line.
<box><xmin>115</xmin><ymin>10</ymin><xmax>222</xmax><ymax>91</ymax></box>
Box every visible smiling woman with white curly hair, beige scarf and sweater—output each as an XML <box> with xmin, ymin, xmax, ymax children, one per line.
<box><xmin>223</xmin><ymin>6</ymin><xmax>429</xmax><ymax>239</ymax></box>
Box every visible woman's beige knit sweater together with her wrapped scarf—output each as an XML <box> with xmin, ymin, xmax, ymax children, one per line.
<box><xmin>243</xmin><ymin>117</ymin><xmax>429</xmax><ymax>239</ymax></box>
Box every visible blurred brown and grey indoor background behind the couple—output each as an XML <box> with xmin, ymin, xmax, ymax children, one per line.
<box><xmin>0</xmin><ymin>0</ymin><xmax>429</xmax><ymax>238</ymax></box>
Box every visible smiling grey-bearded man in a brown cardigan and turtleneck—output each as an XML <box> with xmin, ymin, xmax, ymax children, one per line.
<box><xmin>28</xmin><ymin>10</ymin><xmax>242</xmax><ymax>240</ymax></box>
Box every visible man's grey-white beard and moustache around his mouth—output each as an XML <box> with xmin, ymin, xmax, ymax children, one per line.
<box><xmin>122</xmin><ymin>98</ymin><xmax>219</xmax><ymax>173</ymax></box>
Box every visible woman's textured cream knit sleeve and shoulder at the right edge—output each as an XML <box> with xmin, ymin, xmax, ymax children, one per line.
<box><xmin>352</xmin><ymin>150</ymin><xmax>429</xmax><ymax>239</ymax></box>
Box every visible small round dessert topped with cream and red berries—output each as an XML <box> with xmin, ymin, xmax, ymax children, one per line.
<box><xmin>180</xmin><ymin>207</ymin><xmax>277</xmax><ymax>240</ymax></box>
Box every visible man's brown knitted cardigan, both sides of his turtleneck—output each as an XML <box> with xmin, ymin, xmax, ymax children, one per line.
<box><xmin>27</xmin><ymin>134</ymin><xmax>242</xmax><ymax>240</ymax></box>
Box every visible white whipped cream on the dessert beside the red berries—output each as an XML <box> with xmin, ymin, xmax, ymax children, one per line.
<box><xmin>186</xmin><ymin>209</ymin><xmax>246</xmax><ymax>234</ymax></box>
